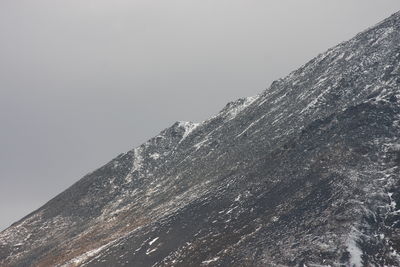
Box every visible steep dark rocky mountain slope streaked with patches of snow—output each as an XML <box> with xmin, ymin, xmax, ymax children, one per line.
<box><xmin>0</xmin><ymin>10</ymin><xmax>400</xmax><ymax>266</ymax></box>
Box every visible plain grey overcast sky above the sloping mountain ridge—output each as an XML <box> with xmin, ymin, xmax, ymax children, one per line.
<box><xmin>0</xmin><ymin>0</ymin><xmax>400</xmax><ymax>230</ymax></box>
